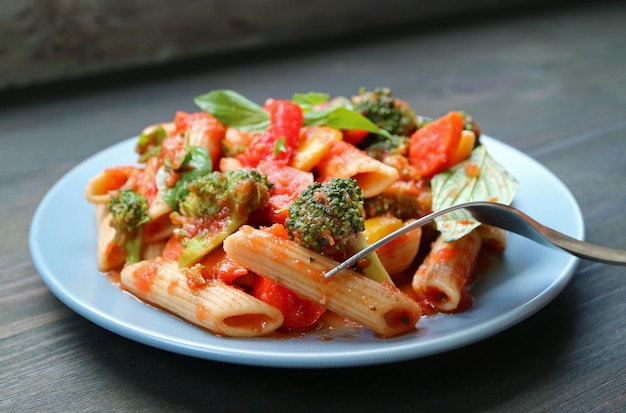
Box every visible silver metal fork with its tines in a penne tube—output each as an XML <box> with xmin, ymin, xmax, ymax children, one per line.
<box><xmin>324</xmin><ymin>201</ymin><xmax>626</xmax><ymax>278</ymax></box>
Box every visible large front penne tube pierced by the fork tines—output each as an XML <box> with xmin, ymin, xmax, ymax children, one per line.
<box><xmin>224</xmin><ymin>226</ymin><xmax>422</xmax><ymax>337</ymax></box>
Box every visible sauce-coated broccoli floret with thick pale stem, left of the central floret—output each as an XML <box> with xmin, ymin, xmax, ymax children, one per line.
<box><xmin>172</xmin><ymin>169</ymin><xmax>272</xmax><ymax>267</ymax></box>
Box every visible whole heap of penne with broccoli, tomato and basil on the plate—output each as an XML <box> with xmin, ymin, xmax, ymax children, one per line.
<box><xmin>85</xmin><ymin>88</ymin><xmax>517</xmax><ymax>337</ymax></box>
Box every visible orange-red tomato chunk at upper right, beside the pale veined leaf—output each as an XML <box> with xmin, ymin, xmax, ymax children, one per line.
<box><xmin>409</xmin><ymin>112</ymin><xmax>463</xmax><ymax>177</ymax></box>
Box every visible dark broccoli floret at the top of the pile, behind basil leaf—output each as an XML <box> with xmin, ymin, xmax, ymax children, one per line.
<box><xmin>351</xmin><ymin>88</ymin><xmax>417</xmax><ymax>136</ymax></box>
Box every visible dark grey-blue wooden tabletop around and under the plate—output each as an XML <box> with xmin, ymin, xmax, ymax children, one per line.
<box><xmin>0</xmin><ymin>3</ymin><xmax>626</xmax><ymax>412</ymax></box>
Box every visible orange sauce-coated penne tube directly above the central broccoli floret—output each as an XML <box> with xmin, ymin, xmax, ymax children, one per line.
<box><xmin>316</xmin><ymin>141</ymin><xmax>399</xmax><ymax>198</ymax></box>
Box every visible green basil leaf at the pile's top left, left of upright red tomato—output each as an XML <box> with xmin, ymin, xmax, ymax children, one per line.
<box><xmin>194</xmin><ymin>90</ymin><xmax>270</xmax><ymax>132</ymax></box>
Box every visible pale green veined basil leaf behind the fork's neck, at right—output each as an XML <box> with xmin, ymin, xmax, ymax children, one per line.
<box><xmin>430</xmin><ymin>145</ymin><xmax>518</xmax><ymax>241</ymax></box>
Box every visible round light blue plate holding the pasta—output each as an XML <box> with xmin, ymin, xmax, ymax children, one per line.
<box><xmin>29</xmin><ymin>136</ymin><xmax>584</xmax><ymax>368</ymax></box>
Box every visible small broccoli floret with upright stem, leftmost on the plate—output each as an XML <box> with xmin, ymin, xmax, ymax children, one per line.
<box><xmin>107</xmin><ymin>189</ymin><xmax>150</xmax><ymax>264</ymax></box>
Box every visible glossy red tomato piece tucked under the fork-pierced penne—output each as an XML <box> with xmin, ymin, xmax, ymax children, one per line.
<box><xmin>252</xmin><ymin>276</ymin><xmax>326</xmax><ymax>328</ymax></box>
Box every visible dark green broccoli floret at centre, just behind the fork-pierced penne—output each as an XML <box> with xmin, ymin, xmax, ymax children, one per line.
<box><xmin>285</xmin><ymin>178</ymin><xmax>392</xmax><ymax>283</ymax></box>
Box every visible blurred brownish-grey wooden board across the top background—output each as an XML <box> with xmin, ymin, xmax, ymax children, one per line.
<box><xmin>0</xmin><ymin>0</ymin><xmax>571</xmax><ymax>89</ymax></box>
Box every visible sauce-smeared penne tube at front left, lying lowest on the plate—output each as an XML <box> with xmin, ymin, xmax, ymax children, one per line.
<box><xmin>120</xmin><ymin>257</ymin><xmax>283</xmax><ymax>337</ymax></box>
